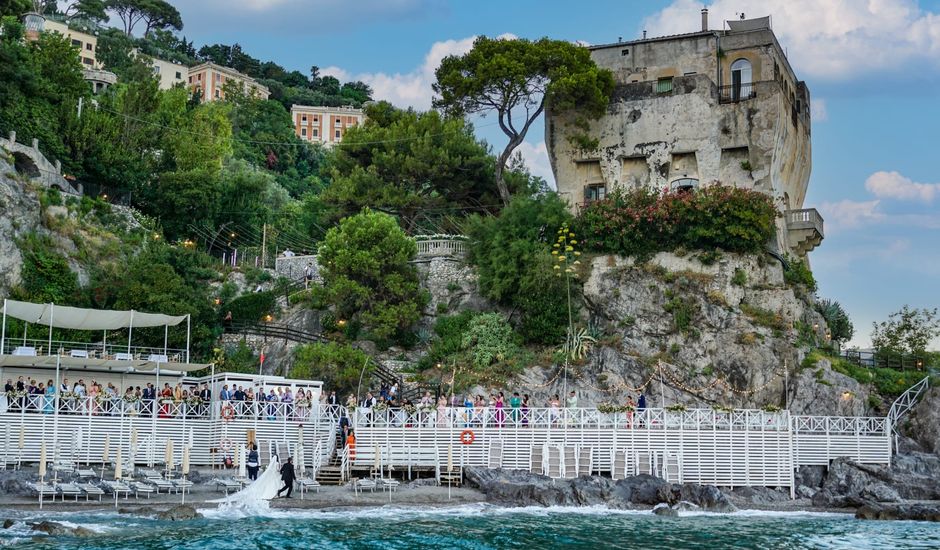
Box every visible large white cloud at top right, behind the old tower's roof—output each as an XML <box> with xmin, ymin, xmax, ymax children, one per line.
<box><xmin>643</xmin><ymin>0</ymin><xmax>940</xmax><ymax>79</ymax></box>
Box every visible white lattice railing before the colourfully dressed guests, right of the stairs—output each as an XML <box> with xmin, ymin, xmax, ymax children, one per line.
<box><xmin>353</xmin><ymin>407</ymin><xmax>789</xmax><ymax>431</ymax></box>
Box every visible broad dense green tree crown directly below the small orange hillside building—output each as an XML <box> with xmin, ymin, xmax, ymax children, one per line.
<box><xmin>323</xmin><ymin>102</ymin><xmax>506</xmax><ymax>230</ymax></box>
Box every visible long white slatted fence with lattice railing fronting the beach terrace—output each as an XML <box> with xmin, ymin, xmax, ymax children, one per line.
<box><xmin>0</xmin><ymin>402</ymin><xmax>891</xmax><ymax>487</ymax></box>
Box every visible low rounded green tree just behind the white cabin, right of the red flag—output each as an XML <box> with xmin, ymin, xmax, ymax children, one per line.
<box><xmin>290</xmin><ymin>342</ymin><xmax>373</xmax><ymax>398</ymax></box>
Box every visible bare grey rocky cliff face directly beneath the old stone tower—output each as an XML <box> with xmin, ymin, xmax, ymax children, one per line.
<box><xmin>506</xmin><ymin>253</ymin><xmax>867</xmax><ymax>415</ymax></box>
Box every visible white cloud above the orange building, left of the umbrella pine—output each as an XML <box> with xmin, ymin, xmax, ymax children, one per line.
<box><xmin>321</xmin><ymin>34</ymin><xmax>515</xmax><ymax>110</ymax></box>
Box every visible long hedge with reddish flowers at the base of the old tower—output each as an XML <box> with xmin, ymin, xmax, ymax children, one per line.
<box><xmin>576</xmin><ymin>185</ymin><xmax>777</xmax><ymax>257</ymax></box>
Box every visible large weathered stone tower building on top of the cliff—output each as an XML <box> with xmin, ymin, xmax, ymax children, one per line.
<box><xmin>545</xmin><ymin>9</ymin><xmax>823</xmax><ymax>256</ymax></box>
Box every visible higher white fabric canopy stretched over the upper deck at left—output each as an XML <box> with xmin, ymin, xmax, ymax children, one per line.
<box><xmin>4</xmin><ymin>300</ymin><xmax>186</xmax><ymax>330</ymax></box>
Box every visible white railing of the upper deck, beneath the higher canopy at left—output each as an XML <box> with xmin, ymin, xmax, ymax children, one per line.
<box><xmin>0</xmin><ymin>338</ymin><xmax>186</xmax><ymax>363</ymax></box>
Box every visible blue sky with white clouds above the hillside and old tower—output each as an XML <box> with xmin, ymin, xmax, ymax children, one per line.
<box><xmin>163</xmin><ymin>0</ymin><xmax>940</xmax><ymax>348</ymax></box>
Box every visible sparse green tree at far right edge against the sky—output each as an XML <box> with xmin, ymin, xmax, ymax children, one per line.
<box><xmin>871</xmin><ymin>305</ymin><xmax>940</xmax><ymax>356</ymax></box>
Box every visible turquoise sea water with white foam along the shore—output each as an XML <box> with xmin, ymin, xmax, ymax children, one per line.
<box><xmin>0</xmin><ymin>505</ymin><xmax>940</xmax><ymax>550</ymax></box>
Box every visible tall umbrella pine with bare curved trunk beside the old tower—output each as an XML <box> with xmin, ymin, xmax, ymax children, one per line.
<box><xmin>434</xmin><ymin>36</ymin><xmax>614</xmax><ymax>204</ymax></box>
